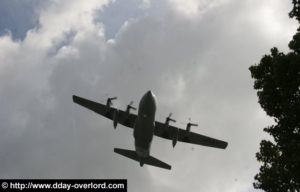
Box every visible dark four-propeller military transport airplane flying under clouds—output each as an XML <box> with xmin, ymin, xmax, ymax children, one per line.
<box><xmin>73</xmin><ymin>91</ymin><xmax>228</xmax><ymax>169</ymax></box>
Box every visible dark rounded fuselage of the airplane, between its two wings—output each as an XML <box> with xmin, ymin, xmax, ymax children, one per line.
<box><xmin>133</xmin><ymin>91</ymin><xmax>156</xmax><ymax>159</ymax></box>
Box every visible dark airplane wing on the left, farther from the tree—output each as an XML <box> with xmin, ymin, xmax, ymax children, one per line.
<box><xmin>73</xmin><ymin>95</ymin><xmax>136</xmax><ymax>128</ymax></box>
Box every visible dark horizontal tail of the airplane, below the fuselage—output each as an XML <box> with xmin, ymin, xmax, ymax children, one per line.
<box><xmin>114</xmin><ymin>148</ymin><xmax>171</xmax><ymax>169</ymax></box>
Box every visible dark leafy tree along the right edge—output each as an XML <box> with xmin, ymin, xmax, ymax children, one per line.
<box><xmin>249</xmin><ymin>0</ymin><xmax>300</xmax><ymax>192</ymax></box>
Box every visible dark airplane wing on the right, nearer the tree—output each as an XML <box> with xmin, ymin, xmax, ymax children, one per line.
<box><xmin>154</xmin><ymin>122</ymin><xmax>228</xmax><ymax>149</ymax></box>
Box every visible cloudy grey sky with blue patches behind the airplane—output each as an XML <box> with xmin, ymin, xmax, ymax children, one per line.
<box><xmin>0</xmin><ymin>0</ymin><xmax>297</xmax><ymax>192</ymax></box>
